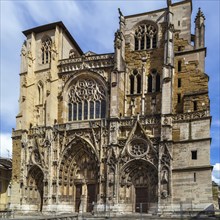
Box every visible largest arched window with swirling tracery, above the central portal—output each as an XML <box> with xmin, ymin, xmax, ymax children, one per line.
<box><xmin>68</xmin><ymin>79</ymin><xmax>106</xmax><ymax>121</ymax></box>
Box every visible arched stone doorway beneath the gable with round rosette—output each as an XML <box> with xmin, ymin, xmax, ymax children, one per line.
<box><xmin>120</xmin><ymin>159</ymin><xmax>158</xmax><ymax>213</ymax></box>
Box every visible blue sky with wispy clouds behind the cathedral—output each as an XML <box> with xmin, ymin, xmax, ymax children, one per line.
<box><xmin>0</xmin><ymin>0</ymin><xmax>220</xmax><ymax>182</ymax></box>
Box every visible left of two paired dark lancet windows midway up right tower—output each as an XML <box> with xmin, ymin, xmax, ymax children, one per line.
<box><xmin>130</xmin><ymin>69</ymin><xmax>142</xmax><ymax>94</ymax></box>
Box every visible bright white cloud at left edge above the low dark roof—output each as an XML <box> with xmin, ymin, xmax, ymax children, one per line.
<box><xmin>0</xmin><ymin>133</ymin><xmax>12</xmax><ymax>157</ymax></box>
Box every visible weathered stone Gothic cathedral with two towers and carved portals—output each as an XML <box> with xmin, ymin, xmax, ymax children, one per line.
<box><xmin>10</xmin><ymin>0</ymin><xmax>212</xmax><ymax>214</ymax></box>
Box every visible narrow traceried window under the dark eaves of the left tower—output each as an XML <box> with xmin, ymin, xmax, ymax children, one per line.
<box><xmin>41</xmin><ymin>36</ymin><xmax>52</xmax><ymax>64</ymax></box>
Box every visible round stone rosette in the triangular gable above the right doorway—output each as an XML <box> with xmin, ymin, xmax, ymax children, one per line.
<box><xmin>128</xmin><ymin>139</ymin><xmax>148</xmax><ymax>157</ymax></box>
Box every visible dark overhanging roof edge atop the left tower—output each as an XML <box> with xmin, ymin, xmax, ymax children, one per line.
<box><xmin>22</xmin><ymin>21</ymin><xmax>83</xmax><ymax>55</ymax></box>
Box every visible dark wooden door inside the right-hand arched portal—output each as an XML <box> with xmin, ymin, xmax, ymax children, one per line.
<box><xmin>135</xmin><ymin>187</ymin><xmax>148</xmax><ymax>213</ymax></box>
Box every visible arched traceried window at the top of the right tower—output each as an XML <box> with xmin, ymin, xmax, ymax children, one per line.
<box><xmin>134</xmin><ymin>24</ymin><xmax>157</xmax><ymax>50</ymax></box>
